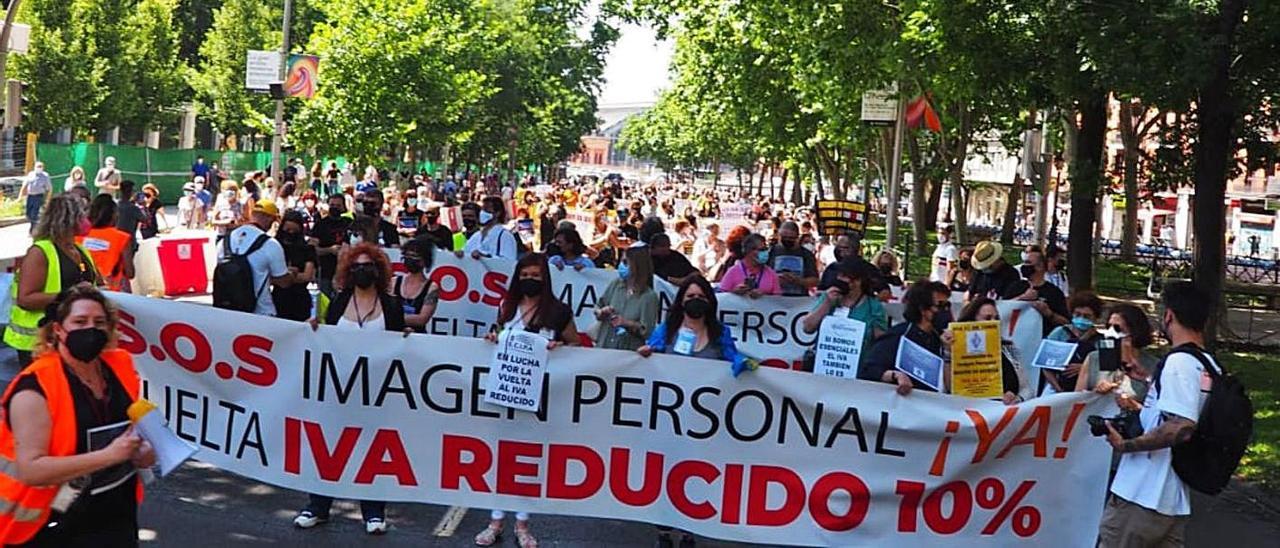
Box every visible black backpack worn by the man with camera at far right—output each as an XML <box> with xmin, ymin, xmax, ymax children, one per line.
<box><xmin>1156</xmin><ymin>344</ymin><xmax>1253</xmax><ymax>494</ymax></box>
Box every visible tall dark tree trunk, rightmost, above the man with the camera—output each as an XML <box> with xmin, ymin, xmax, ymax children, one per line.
<box><xmin>1193</xmin><ymin>0</ymin><xmax>1244</xmax><ymax>344</ymax></box>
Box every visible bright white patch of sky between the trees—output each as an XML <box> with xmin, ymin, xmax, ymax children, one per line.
<box><xmin>599</xmin><ymin>24</ymin><xmax>672</xmax><ymax>106</ymax></box>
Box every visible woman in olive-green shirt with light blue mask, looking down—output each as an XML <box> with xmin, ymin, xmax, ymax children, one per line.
<box><xmin>595</xmin><ymin>243</ymin><xmax>660</xmax><ymax>350</ymax></box>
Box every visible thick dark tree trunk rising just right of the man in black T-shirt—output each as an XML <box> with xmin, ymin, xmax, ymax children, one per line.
<box><xmin>1066</xmin><ymin>90</ymin><xmax>1107</xmax><ymax>292</ymax></box>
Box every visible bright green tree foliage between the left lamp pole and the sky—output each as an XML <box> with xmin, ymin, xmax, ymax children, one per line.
<box><xmin>293</xmin><ymin>0</ymin><xmax>617</xmax><ymax>170</ymax></box>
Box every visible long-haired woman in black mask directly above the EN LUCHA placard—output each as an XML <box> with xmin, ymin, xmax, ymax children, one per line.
<box><xmin>475</xmin><ymin>252</ymin><xmax>580</xmax><ymax>548</ymax></box>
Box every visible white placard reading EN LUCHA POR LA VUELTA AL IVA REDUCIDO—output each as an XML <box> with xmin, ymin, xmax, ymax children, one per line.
<box><xmin>484</xmin><ymin>329</ymin><xmax>548</xmax><ymax>411</ymax></box>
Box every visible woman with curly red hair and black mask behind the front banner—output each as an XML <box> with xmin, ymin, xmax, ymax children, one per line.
<box><xmin>293</xmin><ymin>242</ymin><xmax>412</xmax><ymax>535</ymax></box>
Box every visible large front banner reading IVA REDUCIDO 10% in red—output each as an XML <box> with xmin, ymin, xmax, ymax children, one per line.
<box><xmin>113</xmin><ymin>294</ymin><xmax>1111</xmax><ymax>547</ymax></box>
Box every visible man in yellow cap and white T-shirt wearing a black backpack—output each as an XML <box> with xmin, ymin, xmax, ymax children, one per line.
<box><xmin>214</xmin><ymin>198</ymin><xmax>294</xmax><ymax>316</ymax></box>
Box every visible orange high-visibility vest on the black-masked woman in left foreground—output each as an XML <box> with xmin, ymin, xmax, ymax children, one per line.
<box><xmin>0</xmin><ymin>350</ymin><xmax>142</xmax><ymax>545</ymax></box>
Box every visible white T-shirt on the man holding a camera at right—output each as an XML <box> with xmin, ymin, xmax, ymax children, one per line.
<box><xmin>1111</xmin><ymin>353</ymin><xmax>1221</xmax><ymax>516</ymax></box>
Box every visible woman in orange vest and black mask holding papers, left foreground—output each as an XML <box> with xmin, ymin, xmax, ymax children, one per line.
<box><xmin>0</xmin><ymin>284</ymin><xmax>155</xmax><ymax>547</ymax></box>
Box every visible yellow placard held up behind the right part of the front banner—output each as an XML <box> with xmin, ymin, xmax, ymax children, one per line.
<box><xmin>948</xmin><ymin>321</ymin><xmax>1005</xmax><ymax>398</ymax></box>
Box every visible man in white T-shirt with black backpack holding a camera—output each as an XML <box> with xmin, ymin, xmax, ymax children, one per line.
<box><xmin>1098</xmin><ymin>282</ymin><xmax>1253</xmax><ymax>547</ymax></box>
